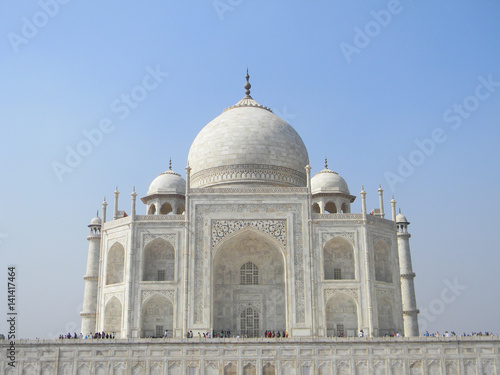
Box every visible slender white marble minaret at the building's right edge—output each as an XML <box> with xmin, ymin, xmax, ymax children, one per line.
<box><xmin>396</xmin><ymin>213</ymin><xmax>420</xmax><ymax>337</ymax></box>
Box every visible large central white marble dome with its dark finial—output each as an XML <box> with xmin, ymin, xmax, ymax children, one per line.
<box><xmin>188</xmin><ymin>74</ymin><xmax>309</xmax><ymax>188</ymax></box>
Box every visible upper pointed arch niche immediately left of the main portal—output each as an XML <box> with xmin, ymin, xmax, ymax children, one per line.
<box><xmin>142</xmin><ymin>238</ymin><xmax>175</xmax><ymax>281</ymax></box>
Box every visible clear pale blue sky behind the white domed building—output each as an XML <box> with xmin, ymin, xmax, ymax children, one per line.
<box><xmin>0</xmin><ymin>0</ymin><xmax>500</xmax><ymax>338</ymax></box>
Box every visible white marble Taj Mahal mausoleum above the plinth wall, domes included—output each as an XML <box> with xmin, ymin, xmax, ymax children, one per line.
<box><xmin>81</xmin><ymin>74</ymin><xmax>418</xmax><ymax>338</ymax></box>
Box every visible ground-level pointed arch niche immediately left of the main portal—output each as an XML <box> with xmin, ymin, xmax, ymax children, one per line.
<box><xmin>141</xmin><ymin>293</ymin><xmax>174</xmax><ymax>337</ymax></box>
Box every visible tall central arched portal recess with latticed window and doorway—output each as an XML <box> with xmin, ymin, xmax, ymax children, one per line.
<box><xmin>212</xmin><ymin>229</ymin><xmax>286</xmax><ymax>337</ymax></box>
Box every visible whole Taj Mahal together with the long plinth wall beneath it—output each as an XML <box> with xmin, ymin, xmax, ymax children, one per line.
<box><xmin>0</xmin><ymin>72</ymin><xmax>500</xmax><ymax>375</ymax></box>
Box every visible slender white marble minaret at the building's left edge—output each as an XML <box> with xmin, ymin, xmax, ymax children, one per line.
<box><xmin>80</xmin><ymin>215</ymin><xmax>102</xmax><ymax>335</ymax></box>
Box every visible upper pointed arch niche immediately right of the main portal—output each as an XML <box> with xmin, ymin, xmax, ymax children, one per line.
<box><xmin>323</xmin><ymin>237</ymin><xmax>355</xmax><ymax>280</ymax></box>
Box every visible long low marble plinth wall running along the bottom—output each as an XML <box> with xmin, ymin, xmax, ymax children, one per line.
<box><xmin>0</xmin><ymin>336</ymin><xmax>500</xmax><ymax>375</ymax></box>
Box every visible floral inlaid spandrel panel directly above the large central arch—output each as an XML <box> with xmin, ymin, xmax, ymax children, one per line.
<box><xmin>212</xmin><ymin>219</ymin><xmax>286</xmax><ymax>248</ymax></box>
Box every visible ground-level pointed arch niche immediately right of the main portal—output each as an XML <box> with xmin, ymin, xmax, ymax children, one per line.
<box><xmin>325</xmin><ymin>292</ymin><xmax>359</xmax><ymax>337</ymax></box>
